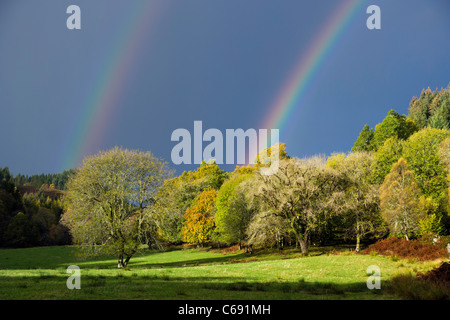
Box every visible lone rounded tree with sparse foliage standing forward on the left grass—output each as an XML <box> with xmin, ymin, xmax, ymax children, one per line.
<box><xmin>63</xmin><ymin>147</ymin><xmax>170</xmax><ymax>268</ymax></box>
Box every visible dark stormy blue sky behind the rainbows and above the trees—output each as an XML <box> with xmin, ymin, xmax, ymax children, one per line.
<box><xmin>0</xmin><ymin>0</ymin><xmax>450</xmax><ymax>174</ymax></box>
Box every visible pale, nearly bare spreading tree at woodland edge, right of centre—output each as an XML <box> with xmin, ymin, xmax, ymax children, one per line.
<box><xmin>251</xmin><ymin>157</ymin><xmax>344</xmax><ymax>253</ymax></box>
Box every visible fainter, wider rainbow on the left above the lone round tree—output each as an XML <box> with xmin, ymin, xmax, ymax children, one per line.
<box><xmin>61</xmin><ymin>0</ymin><xmax>163</xmax><ymax>169</ymax></box>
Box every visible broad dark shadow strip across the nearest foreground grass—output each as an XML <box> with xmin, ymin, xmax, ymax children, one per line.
<box><xmin>0</xmin><ymin>274</ymin><xmax>382</xmax><ymax>300</ymax></box>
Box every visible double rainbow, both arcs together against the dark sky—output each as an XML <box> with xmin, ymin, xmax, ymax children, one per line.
<box><xmin>61</xmin><ymin>0</ymin><xmax>365</xmax><ymax>169</ymax></box>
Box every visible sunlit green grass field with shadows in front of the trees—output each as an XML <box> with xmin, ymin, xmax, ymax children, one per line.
<box><xmin>0</xmin><ymin>246</ymin><xmax>439</xmax><ymax>300</ymax></box>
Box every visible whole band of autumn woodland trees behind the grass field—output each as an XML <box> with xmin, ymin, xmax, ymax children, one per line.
<box><xmin>0</xmin><ymin>86</ymin><xmax>450</xmax><ymax>258</ymax></box>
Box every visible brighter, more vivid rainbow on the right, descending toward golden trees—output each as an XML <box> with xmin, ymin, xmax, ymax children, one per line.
<box><xmin>262</xmin><ymin>0</ymin><xmax>364</xmax><ymax>136</ymax></box>
